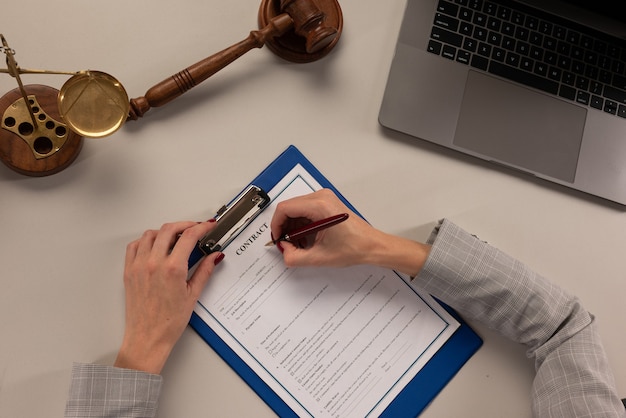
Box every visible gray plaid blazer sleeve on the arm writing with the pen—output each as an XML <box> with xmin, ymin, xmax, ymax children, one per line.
<box><xmin>413</xmin><ymin>220</ymin><xmax>626</xmax><ymax>418</ymax></box>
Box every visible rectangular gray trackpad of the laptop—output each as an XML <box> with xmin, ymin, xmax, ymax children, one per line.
<box><xmin>454</xmin><ymin>71</ymin><xmax>587</xmax><ymax>182</ymax></box>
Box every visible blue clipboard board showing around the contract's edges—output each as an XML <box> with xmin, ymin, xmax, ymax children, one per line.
<box><xmin>189</xmin><ymin>145</ymin><xmax>482</xmax><ymax>418</ymax></box>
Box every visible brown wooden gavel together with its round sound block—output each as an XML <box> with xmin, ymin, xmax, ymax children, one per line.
<box><xmin>128</xmin><ymin>0</ymin><xmax>343</xmax><ymax>120</ymax></box>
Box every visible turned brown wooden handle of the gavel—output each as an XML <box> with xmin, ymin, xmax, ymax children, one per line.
<box><xmin>128</xmin><ymin>13</ymin><xmax>293</xmax><ymax>120</ymax></box>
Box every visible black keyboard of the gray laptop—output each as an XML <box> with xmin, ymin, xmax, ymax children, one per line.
<box><xmin>428</xmin><ymin>0</ymin><xmax>626</xmax><ymax>118</ymax></box>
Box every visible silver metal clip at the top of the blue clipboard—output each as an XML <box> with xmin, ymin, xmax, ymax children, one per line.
<box><xmin>198</xmin><ymin>185</ymin><xmax>270</xmax><ymax>255</ymax></box>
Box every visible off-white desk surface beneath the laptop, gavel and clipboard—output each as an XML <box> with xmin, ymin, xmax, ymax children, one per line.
<box><xmin>0</xmin><ymin>0</ymin><xmax>626</xmax><ymax>418</ymax></box>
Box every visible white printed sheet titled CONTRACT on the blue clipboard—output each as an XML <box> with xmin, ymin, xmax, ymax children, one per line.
<box><xmin>195</xmin><ymin>166</ymin><xmax>459</xmax><ymax>418</ymax></box>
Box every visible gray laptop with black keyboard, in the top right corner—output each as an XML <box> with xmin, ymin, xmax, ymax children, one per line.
<box><xmin>379</xmin><ymin>0</ymin><xmax>626</xmax><ymax>205</ymax></box>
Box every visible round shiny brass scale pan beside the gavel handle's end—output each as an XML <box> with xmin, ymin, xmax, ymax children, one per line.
<box><xmin>58</xmin><ymin>70</ymin><xmax>130</xmax><ymax>138</ymax></box>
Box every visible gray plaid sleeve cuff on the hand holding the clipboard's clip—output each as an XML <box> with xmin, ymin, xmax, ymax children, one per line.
<box><xmin>65</xmin><ymin>363</ymin><xmax>163</xmax><ymax>418</ymax></box>
